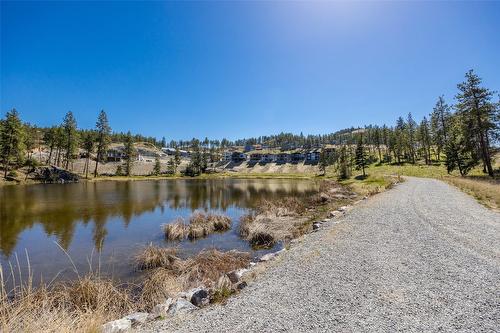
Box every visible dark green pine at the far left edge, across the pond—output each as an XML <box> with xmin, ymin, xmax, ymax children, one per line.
<box><xmin>0</xmin><ymin>109</ymin><xmax>25</xmax><ymax>177</ymax></box>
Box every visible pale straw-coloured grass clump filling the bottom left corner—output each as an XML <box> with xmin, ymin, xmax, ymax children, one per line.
<box><xmin>0</xmin><ymin>268</ymin><xmax>133</xmax><ymax>333</ymax></box>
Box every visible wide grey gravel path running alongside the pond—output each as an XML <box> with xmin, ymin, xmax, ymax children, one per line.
<box><xmin>138</xmin><ymin>178</ymin><xmax>500</xmax><ymax>332</ymax></box>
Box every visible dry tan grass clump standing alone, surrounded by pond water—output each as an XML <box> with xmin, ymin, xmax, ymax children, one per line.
<box><xmin>163</xmin><ymin>211</ymin><xmax>231</xmax><ymax>240</ymax></box>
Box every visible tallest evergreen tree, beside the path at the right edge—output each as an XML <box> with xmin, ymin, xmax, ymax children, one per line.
<box><xmin>456</xmin><ymin>70</ymin><xmax>497</xmax><ymax>177</ymax></box>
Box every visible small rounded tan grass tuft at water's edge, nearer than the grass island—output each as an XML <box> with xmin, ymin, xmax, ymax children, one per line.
<box><xmin>134</xmin><ymin>244</ymin><xmax>178</xmax><ymax>270</ymax></box>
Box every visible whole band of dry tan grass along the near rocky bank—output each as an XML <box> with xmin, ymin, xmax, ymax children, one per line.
<box><xmin>0</xmin><ymin>244</ymin><xmax>250</xmax><ymax>333</ymax></box>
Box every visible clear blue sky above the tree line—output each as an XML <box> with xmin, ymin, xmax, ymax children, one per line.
<box><xmin>0</xmin><ymin>1</ymin><xmax>500</xmax><ymax>139</ymax></box>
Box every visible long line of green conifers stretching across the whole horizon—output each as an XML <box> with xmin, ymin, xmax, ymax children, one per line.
<box><xmin>0</xmin><ymin>70</ymin><xmax>500</xmax><ymax>177</ymax></box>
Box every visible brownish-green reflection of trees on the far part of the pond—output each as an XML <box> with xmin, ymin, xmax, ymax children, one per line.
<box><xmin>0</xmin><ymin>179</ymin><xmax>315</xmax><ymax>256</ymax></box>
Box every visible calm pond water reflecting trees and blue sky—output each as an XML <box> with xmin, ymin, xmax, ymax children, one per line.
<box><xmin>0</xmin><ymin>179</ymin><xmax>317</xmax><ymax>280</ymax></box>
